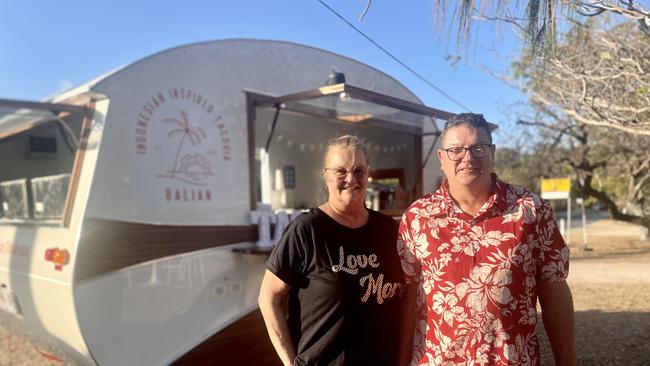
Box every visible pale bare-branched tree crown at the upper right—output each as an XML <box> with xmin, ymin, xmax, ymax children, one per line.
<box><xmin>516</xmin><ymin>18</ymin><xmax>650</xmax><ymax>136</ymax></box>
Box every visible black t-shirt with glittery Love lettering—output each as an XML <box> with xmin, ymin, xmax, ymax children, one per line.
<box><xmin>266</xmin><ymin>208</ymin><xmax>404</xmax><ymax>366</ymax></box>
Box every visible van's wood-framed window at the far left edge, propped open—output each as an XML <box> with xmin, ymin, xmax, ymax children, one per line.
<box><xmin>0</xmin><ymin>100</ymin><xmax>85</xmax><ymax>226</ymax></box>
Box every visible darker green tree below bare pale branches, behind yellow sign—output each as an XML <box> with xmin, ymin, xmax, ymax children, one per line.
<box><xmin>519</xmin><ymin>114</ymin><xmax>650</xmax><ymax>224</ymax></box>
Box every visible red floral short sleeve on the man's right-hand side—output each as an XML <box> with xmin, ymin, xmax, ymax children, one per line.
<box><xmin>537</xmin><ymin>200</ymin><xmax>569</xmax><ymax>282</ymax></box>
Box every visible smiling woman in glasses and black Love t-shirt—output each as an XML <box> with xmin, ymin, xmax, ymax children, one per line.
<box><xmin>259</xmin><ymin>136</ymin><xmax>403</xmax><ymax>366</ymax></box>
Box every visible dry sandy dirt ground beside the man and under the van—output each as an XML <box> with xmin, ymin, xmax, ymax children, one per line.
<box><xmin>0</xmin><ymin>220</ymin><xmax>650</xmax><ymax>366</ymax></box>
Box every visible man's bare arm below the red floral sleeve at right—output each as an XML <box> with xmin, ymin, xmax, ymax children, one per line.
<box><xmin>537</xmin><ymin>281</ymin><xmax>576</xmax><ymax>366</ymax></box>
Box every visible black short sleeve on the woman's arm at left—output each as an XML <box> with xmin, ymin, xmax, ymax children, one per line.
<box><xmin>266</xmin><ymin>214</ymin><xmax>307</xmax><ymax>287</ymax></box>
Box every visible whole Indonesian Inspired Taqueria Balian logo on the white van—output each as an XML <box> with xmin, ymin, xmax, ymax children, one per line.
<box><xmin>135</xmin><ymin>88</ymin><xmax>231</xmax><ymax>197</ymax></box>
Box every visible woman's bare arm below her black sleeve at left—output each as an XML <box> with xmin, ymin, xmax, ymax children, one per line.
<box><xmin>257</xmin><ymin>269</ymin><xmax>296</xmax><ymax>366</ymax></box>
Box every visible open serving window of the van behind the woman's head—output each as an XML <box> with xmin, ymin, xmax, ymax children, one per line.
<box><xmin>247</xmin><ymin>84</ymin><xmax>452</xmax><ymax>215</ymax></box>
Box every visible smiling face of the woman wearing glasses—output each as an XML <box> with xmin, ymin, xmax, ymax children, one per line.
<box><xmin>323</xmin><ymin>146</ymin><xmax>368</xmax><ymax>207</ymax></box>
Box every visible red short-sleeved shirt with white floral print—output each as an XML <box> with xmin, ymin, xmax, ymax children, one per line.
<box><xmin>398</xmin><ymin>175</ymin><xmax>569</xmax><ymax>365</ymax></box>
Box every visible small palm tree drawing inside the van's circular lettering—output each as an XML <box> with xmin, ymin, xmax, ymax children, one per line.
<box><xmin>163</xmin><ymin>110</ymin><xmax>213</xmax><ymax>184</ymax></box>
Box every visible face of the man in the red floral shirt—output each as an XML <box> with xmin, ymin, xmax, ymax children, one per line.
<box><xmin>438</xmin><ymin>125</ymin><xmax>494</xmax><ymax>187</ymax></box>
